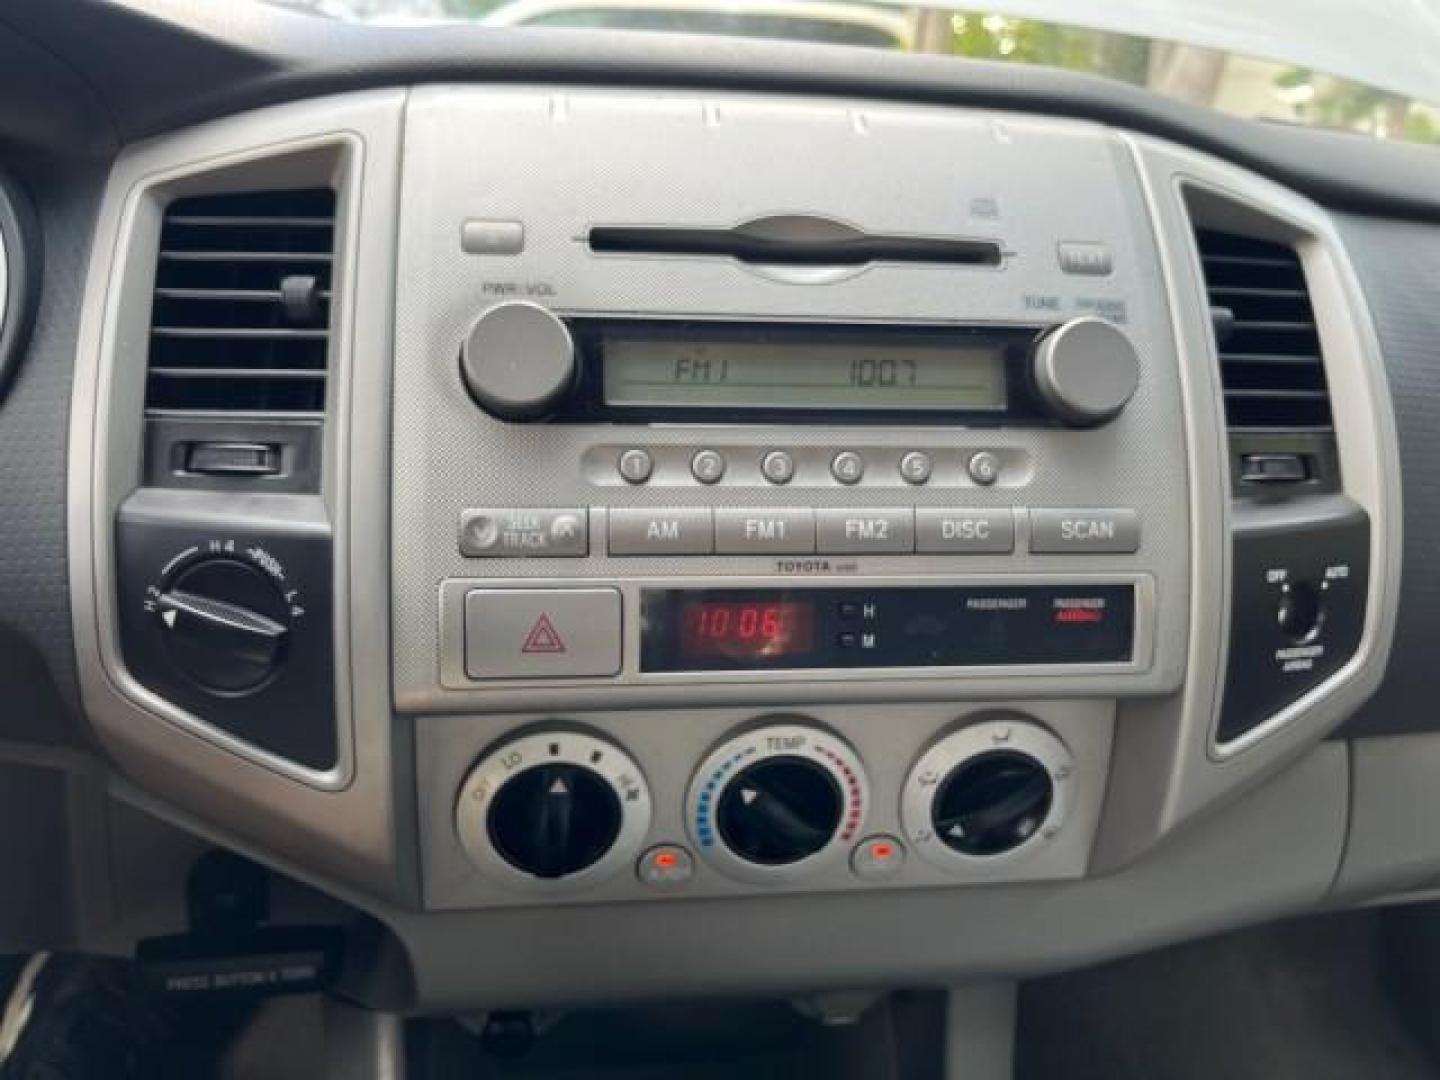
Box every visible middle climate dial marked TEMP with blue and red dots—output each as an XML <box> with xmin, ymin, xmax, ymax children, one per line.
<box><xmin>688</xmin><ymin>723</ymin><xmax>868</xmax><ymax>881</ymax></box>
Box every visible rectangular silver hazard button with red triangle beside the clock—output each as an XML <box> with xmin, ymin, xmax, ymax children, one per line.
<box><xmin>465</xmin><ymin>589</ymin><xmax>621</xmax><ymax>678</ymax></box>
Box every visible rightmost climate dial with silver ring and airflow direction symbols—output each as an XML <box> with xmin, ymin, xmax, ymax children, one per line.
<box><xmin>900</xmin><ymin>714</ymin><xmax>1074</xmax><ymax>870</ymax></box>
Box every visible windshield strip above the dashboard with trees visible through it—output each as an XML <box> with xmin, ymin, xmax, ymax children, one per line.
<box><xmin>274</xmin><ymin>0</ymin><xmax>1440</xmax><ymax>143</ymax></box>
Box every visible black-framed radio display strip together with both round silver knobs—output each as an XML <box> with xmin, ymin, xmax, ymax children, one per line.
<box><xmin>461</xmin><ymin>301</ymin><xmax>1139</xmax><ymax>428</ymax></box>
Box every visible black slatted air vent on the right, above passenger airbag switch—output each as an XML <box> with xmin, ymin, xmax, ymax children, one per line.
<box><xmin>1195</xmin><ymin>229</ymin><xmax>1331</xmax><ymax>431</ymax></box>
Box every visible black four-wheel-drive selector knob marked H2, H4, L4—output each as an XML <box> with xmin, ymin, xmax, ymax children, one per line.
<box><xmin>151</xmin><ymin>556</ymin><xmax>291</xmax><ymax>694</ymax></box>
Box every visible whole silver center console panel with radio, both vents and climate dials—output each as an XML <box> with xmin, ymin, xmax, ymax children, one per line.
<box><xmin>71</xmin><ymin>86</ymin><xmax>1398</xmax><ymax>990</ymax></box>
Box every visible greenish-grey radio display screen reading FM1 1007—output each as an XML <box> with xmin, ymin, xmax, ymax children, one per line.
<box><xmin>600</xmin><ymin>328</ymin><xmax>1008</xmax><ymax>413</ymax></box>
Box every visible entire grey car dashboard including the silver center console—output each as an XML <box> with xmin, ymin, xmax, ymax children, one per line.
<box><xmin>0</xmin><ymin>6</ymin><xmax>1440</xmax><ymax>1011</ymax></box>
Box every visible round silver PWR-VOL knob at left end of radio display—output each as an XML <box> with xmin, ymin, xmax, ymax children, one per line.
<box><xmin>461</xmin><ymin>300</ymin><xmax>576</xmax><ymax>420</ymax></box>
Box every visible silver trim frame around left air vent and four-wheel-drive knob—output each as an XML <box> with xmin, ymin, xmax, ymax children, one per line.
<box><xmin>66</xmin><ymin>91</ymin><xmax>413</xmax><ymax>897</ymax></box>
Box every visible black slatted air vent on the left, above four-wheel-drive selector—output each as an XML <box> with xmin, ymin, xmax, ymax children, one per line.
<box><xmin>145</xmin><ymin>189</ymin><xmax>336</xmax><ymax>416</ymax></box>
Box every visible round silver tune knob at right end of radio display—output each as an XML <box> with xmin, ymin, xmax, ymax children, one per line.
<box><xmin>1031</xmin><ymin>315</ymin><xmax>1140</xmax><ymax>428</ymax></box>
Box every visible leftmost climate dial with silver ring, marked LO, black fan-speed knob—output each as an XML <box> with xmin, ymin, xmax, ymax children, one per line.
<box><xmin>455</xmin><ymin>732</ymin><xmax>651</xmax><ymax>891</ymax></box>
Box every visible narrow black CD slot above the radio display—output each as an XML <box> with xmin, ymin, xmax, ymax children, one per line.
<box><xmin>589</xmin><ymin>216</ymin><xmax>1004</xmax><ymax>266</ymax></box>
